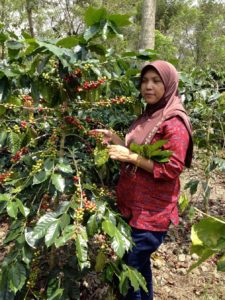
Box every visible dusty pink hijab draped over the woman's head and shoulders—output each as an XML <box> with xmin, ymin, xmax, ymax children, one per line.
<box><xmin>125</xmin><ymin>60</ymin><xmax>193</xmax><ymax>167</ymax></box>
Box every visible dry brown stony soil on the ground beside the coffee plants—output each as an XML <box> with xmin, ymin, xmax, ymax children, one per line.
<box><xmin>0</xmin><ymin>158</ymin><xmax>225</xmax><ymax>300</ymax></box>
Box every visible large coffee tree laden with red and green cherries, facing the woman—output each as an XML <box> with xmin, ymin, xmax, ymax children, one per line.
<box><xmin>0</xmin><ymin>8</ymin><xmax>161</xmax><ymax>300</ymax></box>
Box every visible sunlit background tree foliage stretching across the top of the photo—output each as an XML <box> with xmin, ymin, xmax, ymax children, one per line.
<box><xmin>0</xmin><ymin>0</ymin><xmax>225</xmax><ymax>71</ymax></box>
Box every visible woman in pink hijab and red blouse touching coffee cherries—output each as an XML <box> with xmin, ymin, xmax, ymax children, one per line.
<box><xmin>92</xmin><ymin>61</ymin><xmax>193</xmax><ymax>300</ymax></box>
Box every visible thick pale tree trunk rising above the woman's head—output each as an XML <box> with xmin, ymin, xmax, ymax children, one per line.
<box><xmin>139</xmin><ymin>0</ymin><xmax>156</xmax><ymax>49</ymax></box>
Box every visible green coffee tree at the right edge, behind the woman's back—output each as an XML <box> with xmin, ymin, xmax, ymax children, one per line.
<box><xmin>180</xmin><ymin>69</ymin><xmax>225</xmax><ymax>272</ymax></box>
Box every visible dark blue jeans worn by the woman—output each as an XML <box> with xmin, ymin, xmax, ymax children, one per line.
<box><xmin>122</xmin><ymin>227</ymin><xmax>166</xmax><ymax>300</ymax></box>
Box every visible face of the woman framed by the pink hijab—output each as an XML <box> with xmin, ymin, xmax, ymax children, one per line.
<box><xmin>141</xmin><ymin>70</ymin><xmax>165</xmax><ymax>105</ymax></box>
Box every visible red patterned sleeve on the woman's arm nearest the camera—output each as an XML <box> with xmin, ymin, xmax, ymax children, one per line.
<box><xmin>153</xmin><ymin>117</ymin><xmax>190</xmax><ymax>180</ymax></box>
